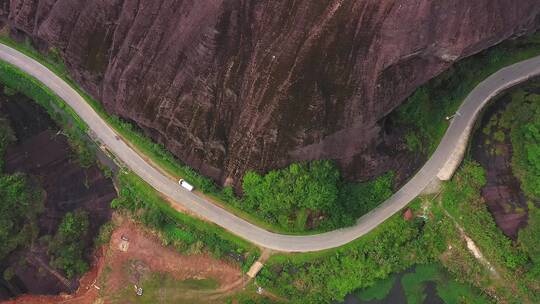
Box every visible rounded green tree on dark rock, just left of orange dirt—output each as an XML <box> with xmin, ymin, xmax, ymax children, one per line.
<box><xmin>49</xmin><ymin>210</ymin><xmax>90</xmax><ymax>278</ymax></box>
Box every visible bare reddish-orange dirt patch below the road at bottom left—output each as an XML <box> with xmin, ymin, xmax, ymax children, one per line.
<box><xmin>5</xmin><ymin>216</ymin><xmax>245</xmax><ymax>304</ymax></box>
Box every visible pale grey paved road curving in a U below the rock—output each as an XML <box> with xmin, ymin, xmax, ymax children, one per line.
<box><xmin>0</xmin><ymin>44</ymin><xmax>540</xmax><ymax>252</ymax></box>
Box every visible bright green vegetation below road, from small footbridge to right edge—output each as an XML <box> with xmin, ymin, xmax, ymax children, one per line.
<box><xmin>257</xmin><ymin>161</ymin><xmax>540</xmax><ymax>303</ymax></box>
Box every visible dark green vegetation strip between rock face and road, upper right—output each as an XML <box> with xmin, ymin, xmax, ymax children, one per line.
<box><xmin>392</xmin><ymin>32</ymin><xmax>540</xmax><ymax>154</ymax></box>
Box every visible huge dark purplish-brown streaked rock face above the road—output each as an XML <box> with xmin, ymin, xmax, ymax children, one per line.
<box><xmin>0</xmin><ymin>0</ymin><xmax>540</xmax><ymax>183</ymax></box>
